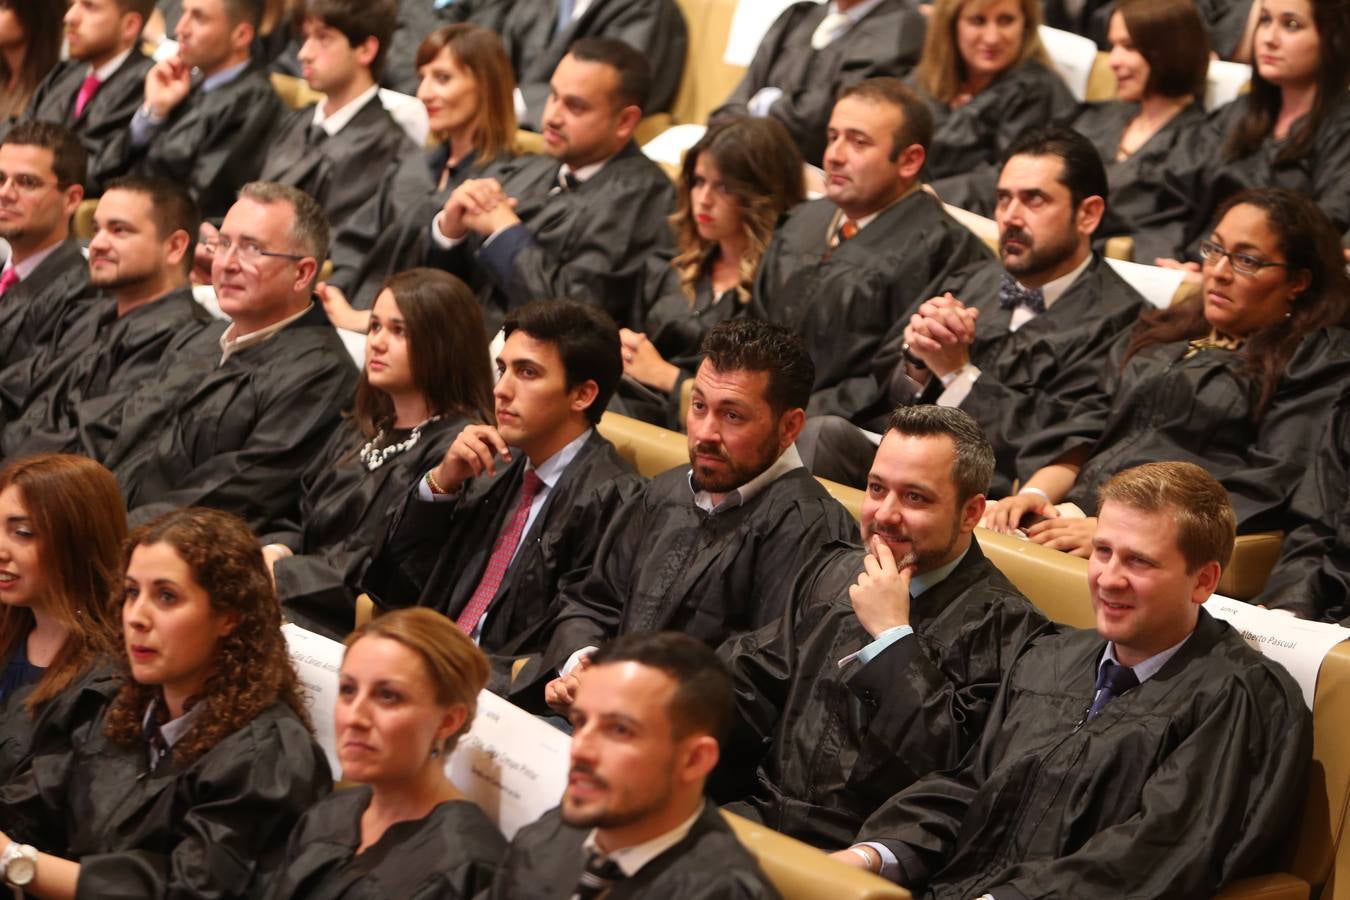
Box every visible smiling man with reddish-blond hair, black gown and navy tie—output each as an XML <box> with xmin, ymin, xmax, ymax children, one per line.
<box><xmin>836</xmin><ymin>463</ymin><xmax>1312</xmax><ymax>900</ymax></box>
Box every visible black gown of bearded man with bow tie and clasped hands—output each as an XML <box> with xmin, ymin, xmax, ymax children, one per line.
<box><xmin>873</xmin><ymin>256</ymin><xmax>1148</xmax><ymax>497</ymax></box>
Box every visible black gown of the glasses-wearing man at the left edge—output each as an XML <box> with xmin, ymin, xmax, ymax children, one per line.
<box><xmin>0</xmin><ymin>239</ymin><xmax>89</xmax><ymax>368</ymax></box>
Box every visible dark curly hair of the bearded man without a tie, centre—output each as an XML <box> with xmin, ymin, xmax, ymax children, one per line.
<box><xmin>701</xmin><ymin>317</ymin><xmax>815</xmax><ymax>416</ymax></box>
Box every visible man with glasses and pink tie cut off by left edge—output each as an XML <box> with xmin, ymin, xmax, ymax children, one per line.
<box><xmin>0</xmin><ymin>121</ymin><xmax>89</xmax><ymax>367</ymax></box>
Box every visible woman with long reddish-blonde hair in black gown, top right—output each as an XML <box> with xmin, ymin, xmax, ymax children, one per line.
<box><xmin>909</xmin><ymin>0</ymin><xmax>1077</xmax><ymax>210</ymax></box>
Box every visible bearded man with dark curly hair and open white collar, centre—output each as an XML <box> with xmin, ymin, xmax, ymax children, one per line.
<box><xmin>526</xmin><ymin>318</ymin><xmax>857</xmax><ymax>711</ymax></box>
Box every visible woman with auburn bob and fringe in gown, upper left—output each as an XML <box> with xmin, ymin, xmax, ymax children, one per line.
<box><xmin>319</xmin><ymin>24</ymin><xmax>516</xmax><ymax>332</ymax></box>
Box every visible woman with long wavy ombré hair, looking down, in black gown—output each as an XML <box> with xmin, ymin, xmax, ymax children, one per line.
<box><xmin>613</xmin><ymin>117</ymin><xmax>806</xmax><ymax>430</ymax></box>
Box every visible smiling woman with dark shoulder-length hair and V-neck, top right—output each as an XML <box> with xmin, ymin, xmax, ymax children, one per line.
<box><xmin>1074</xmin><ymin>0</ymin><xmax>1210</xmax><ymax>262</ymax></box>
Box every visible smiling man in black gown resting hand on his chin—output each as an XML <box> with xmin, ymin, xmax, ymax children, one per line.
<box><xmin>714</xmin><ymin>406</ymin><xmax>1045</xmax><ymax>849</ymax></box>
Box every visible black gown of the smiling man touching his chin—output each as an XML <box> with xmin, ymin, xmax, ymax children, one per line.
<box><xmin>720</xmin><ymin>540</ymin><xmax>1045</xmax><ymax>850</ymax></box>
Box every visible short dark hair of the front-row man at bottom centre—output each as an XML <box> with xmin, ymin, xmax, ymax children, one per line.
<box><xmin>591</xmin><ymin>631</ymin><xmax>734</xmax><ymax>742</ymax></box>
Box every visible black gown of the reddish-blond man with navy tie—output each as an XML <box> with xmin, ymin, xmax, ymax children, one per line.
<box><xmin>859</xmin><ymin>610</ymin><xmax>1312</xmax><ymax>900</ymax></box>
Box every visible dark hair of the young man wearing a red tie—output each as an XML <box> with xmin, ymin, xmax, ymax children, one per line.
<box><xmin>502</xmin><ymin>300</ymin><xmax>624</xmax><ymax>424</ymax></box>
